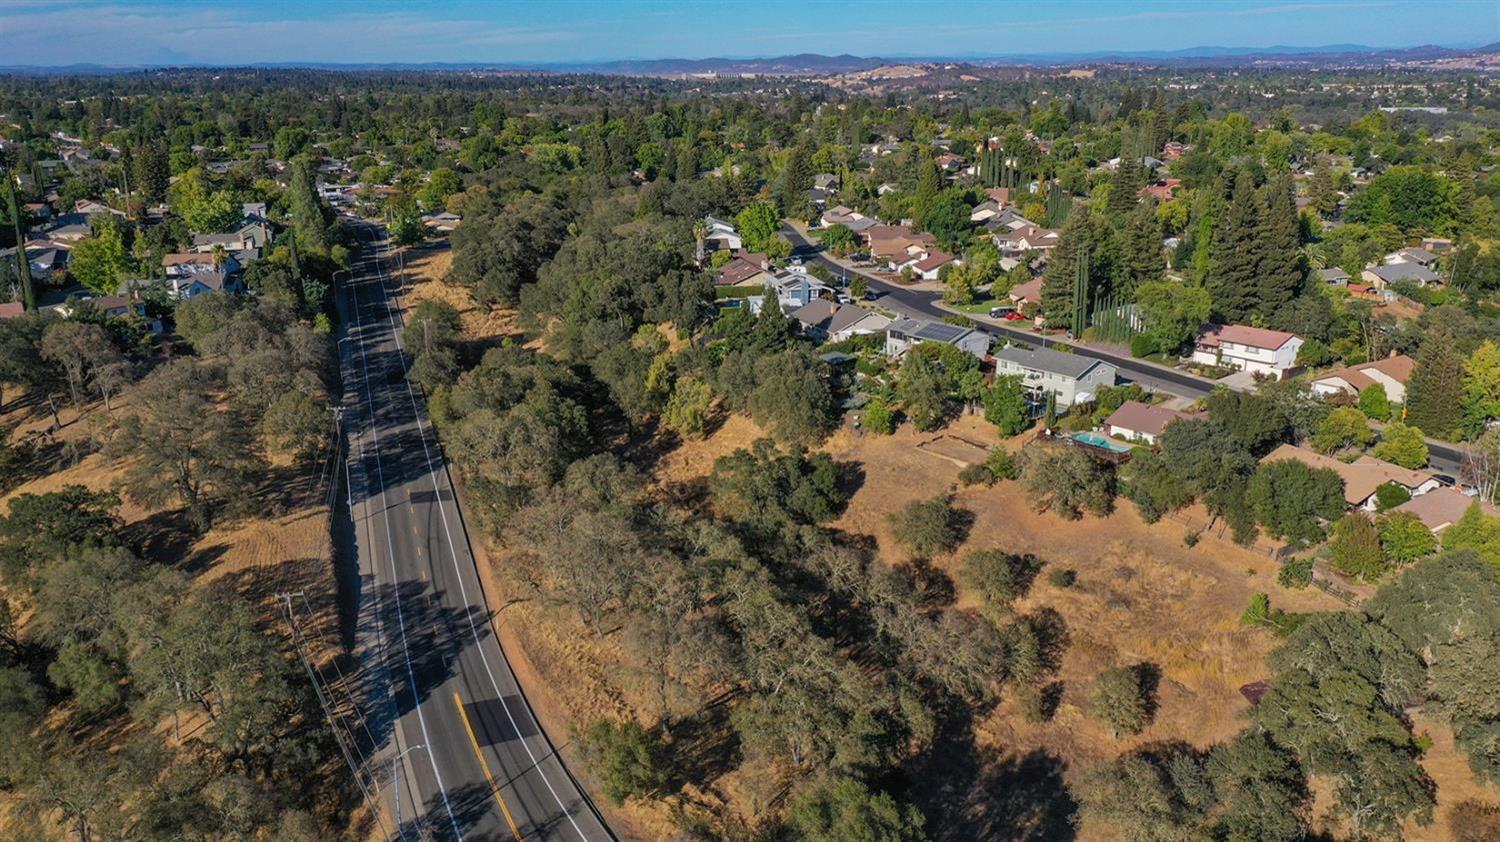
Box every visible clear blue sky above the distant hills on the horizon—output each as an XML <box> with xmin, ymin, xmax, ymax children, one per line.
<box><xmin>0</xmin><ymin>0</ymin><xmax>1500</xmax><ymax>65</ymax></box>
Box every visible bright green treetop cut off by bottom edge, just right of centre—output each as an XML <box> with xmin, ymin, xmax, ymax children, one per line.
<box><xmin>786</xmin><ymin>777</ymin><xmax>927</xmax><ymax>842</ymax></box>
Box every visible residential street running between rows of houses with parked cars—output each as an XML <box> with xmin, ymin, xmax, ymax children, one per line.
<box><xmin>782</xmin><ymin>225</ymin><xmax>1463</xmax><ymax>477</ymax></box>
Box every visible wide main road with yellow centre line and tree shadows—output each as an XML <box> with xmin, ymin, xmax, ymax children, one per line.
<box><xmin>336</xmin><ymin>225</ymin><xmax>614</xmax><ymax>842</ymax></box>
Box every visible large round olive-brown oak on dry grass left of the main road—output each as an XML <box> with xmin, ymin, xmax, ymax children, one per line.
<box><xmin>110</xmin><ymin>360</ymin><xmax>260</xmax><ymax>530</ymax></box>
